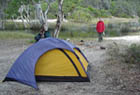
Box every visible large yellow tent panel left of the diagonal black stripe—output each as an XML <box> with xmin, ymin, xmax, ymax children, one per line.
<box><xmin>35</xmin><ymin>49</ymin><xmax>78</xmax><ymax>76</ymax></box>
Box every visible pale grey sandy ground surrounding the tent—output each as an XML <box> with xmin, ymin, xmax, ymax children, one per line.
<box><xmin>0</xmin><ymin>36</ymin><xmax>140</xmax><ymax>95</ymax></box>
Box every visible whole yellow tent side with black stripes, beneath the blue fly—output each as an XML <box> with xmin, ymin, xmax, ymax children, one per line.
<box><xmin>35</xmin><ymin>48</ymin><xmax>88</xmax><ymax>81</ymax></box>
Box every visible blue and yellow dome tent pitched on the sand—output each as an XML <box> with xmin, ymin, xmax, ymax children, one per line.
<box><xmin>4</xmin><ymin>38</ymin><xmax>90</xmax><ymax>89</ymax></box>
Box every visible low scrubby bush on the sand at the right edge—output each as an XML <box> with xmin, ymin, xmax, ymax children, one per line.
<box><xmin>108</xmin><ymin>42</ymin><xmax>140</xmax><ymax>64</ymax></box>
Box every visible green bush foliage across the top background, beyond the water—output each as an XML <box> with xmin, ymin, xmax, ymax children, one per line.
<box><xmin>5</xmin><ymin>0</ymin><xmax>140</xmax><ymax>21</ymax></box>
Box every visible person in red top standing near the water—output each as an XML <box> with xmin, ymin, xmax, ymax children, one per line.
<box><xmin>96</xmin><ymin>18</ymin><xmax>105</xmax><ymax>42</ymax></box>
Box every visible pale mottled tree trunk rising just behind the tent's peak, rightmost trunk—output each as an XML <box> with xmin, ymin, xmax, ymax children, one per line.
<box><xmin>54</xmin><ymin>0</ymin><xmax>63</xmax><ymax>38</ymax></box>
